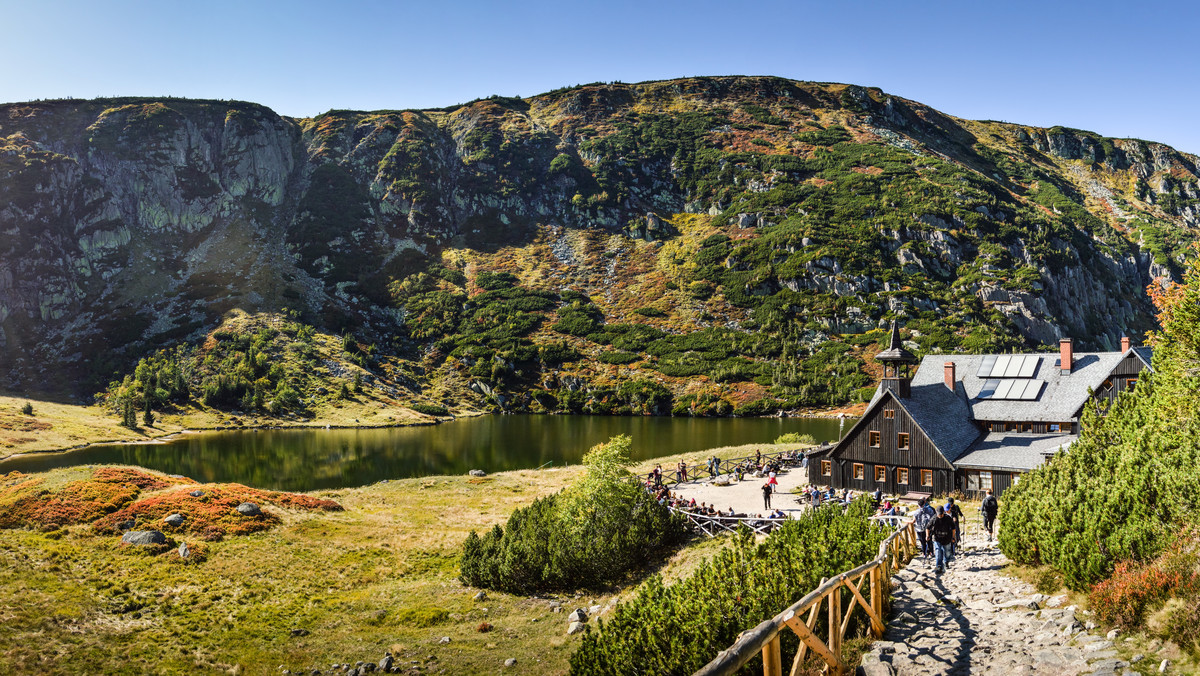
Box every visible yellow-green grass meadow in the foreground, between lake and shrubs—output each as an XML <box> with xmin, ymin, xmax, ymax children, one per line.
<box><xmin>0</xmin><ymin>444</ymin><xmax>811</xmax><ymax>674</ymax></box>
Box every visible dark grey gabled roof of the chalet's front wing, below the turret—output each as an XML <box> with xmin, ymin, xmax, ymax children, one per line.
<box><xmin>839</xmin><ymin>381</ymin><xmax>979</xmax><ymax>462</ymax></box>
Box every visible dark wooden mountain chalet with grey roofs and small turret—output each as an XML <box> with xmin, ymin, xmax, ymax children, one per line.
<box><xmin>809</xmin><ymin>323</ymin><xmax>1151</xmax><ymax>497</ymax></box>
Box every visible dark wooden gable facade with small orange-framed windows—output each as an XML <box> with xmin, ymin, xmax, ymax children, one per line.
<box><xmin>809</xmin><ymin>391</ymin><xmax>955</xmax><ymax>495</ymax></box>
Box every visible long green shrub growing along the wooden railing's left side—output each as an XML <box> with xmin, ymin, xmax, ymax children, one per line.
<box><xmin>571</xmin><ymin>496</ymin><xmax>889</xmax><ymax>675</ymax></box>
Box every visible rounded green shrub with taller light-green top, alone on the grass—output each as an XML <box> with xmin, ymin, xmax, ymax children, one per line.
<box><xmin>461</xmin><ymin>436</ymin><xmax>685</xmax><ymax>594</ymax></box>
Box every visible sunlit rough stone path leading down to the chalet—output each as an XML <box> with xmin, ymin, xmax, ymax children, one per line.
<box><xmin>859</xmin><ymin>534</ymin><xmax>1159</xmax><ymax>676</ymax></box>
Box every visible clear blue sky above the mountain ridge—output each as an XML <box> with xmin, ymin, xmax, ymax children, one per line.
<box><xmin>0</xmin><ymin>0</ymin><xmax>1200</xmax><ymax>154</ymax></box>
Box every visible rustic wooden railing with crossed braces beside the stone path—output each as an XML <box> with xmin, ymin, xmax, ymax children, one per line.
<box><xmin>695</xmin><ymin>521</ymin><xmax>919</xmax><ymax>676</ymax></box>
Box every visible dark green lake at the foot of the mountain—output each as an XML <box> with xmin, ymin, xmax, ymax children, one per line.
<box><xmin>0</xmin><ymin>415</ymin><xmax>853</xmax><ymax>491</ymax></box>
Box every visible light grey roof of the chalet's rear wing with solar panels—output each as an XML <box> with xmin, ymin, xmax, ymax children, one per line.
<box><xmin>912</xmin><ymin>348</ymin><xmax>1142</xmax><ymax>423</ymax></box>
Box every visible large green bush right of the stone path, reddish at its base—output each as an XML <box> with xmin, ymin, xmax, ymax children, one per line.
<box><xmin>1000</xmin><ymin>250</ymin><xmax>1200</xmax><ymax>648</ymax></box>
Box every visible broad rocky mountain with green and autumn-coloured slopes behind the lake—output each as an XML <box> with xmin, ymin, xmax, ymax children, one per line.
<box><xmin>0</xmin><ymin>77</ymin><xmax>1200</xmax><ymax>414</ymax></box>
